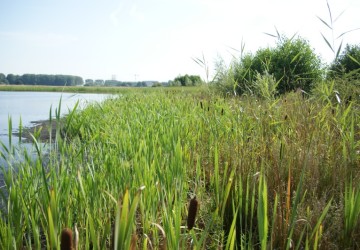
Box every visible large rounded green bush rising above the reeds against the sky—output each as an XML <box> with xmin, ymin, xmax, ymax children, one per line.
<box><xmin>234</xmin><ymin>37</ymin><xmax>322</xmax><ymax>95</ymax></box>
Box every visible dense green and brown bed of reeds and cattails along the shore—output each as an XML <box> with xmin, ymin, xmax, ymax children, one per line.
<box><xmin>0</xmin><ymin>87</ymin><xmax>360</xmax><ymax>249</ymax></box>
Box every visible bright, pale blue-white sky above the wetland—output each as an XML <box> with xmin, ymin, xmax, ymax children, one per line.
<box><xmin>0</xmin><ymin>0</ymin><xmax>360</xmax><ymax>81</ymax></box>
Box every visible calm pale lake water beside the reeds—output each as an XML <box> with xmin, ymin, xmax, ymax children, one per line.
<box><xmin>0</xmin><ymin>91</ymin><xmax>111</xmax><ymax>163</ymax></box>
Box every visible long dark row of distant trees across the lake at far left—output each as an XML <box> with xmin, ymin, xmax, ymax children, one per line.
<box><xmin>0</xmin><ymin>73</ymin><xmax>84</xmax><ymax>86</ymax></box>
